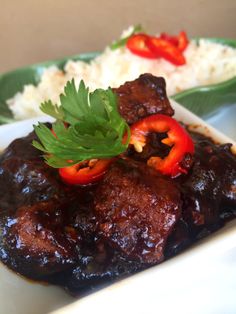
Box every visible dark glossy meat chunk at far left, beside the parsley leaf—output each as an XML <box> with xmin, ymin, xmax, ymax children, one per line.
<box><xmin>0</xmin><ymin>133</ymin><xmax>65</xmax><ymax>210</ymax></box>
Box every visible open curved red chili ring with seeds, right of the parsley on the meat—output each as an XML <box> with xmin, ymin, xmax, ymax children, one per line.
<box><xmin>130</xmin><ymin>114</ymin><xmax>194</xmax><ymax>177</ymax></box>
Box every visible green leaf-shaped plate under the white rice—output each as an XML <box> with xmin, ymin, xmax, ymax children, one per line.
<box><xmin>0</xmin><ymin>38</ymin><xmax>236</xmax><ymax>124</ymax></box>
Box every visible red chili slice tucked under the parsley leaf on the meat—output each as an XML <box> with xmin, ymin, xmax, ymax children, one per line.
<box><xmin>59</xmin><ymin>159</ymin><xmax>113</xmax><ymax>185</ymax></box>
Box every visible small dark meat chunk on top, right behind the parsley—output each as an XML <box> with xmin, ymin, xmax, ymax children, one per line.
<box><xmin>113</xmin><ymin>73</ymin><xmax>174</xmax><ymax>124</ymax></box>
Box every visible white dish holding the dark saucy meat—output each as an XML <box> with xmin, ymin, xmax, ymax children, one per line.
<box><xmin>0</xmin><ymin>103</ymin><xmax>236</xmax><ymax>314</ymax></box>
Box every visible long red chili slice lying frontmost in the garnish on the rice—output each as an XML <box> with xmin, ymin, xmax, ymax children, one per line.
<box><xmin>146</xmin><ymin>37</ymin><xmax>186</xmax><ymax>65</ymax></box>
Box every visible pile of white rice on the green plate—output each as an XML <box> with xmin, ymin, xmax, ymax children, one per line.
<box><xmin>7</xmin><ymin>29</ymin><xmax>236</xmax><ymax>120</ymax></box>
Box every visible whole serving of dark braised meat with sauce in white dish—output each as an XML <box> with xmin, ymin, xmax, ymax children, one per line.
<box><xmin>0</xmin><ymin>74</ymin><xmax>236</xmax><ymax>294</ymax></box>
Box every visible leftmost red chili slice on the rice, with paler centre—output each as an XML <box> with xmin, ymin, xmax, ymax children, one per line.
<box><xmin>126</xmin><ymin>34</ymin><xmax>157</xmax><ymax>59</ymax></box>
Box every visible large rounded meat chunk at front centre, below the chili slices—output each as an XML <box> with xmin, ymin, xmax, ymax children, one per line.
<box><xmin>95</xmin><ymin>160</ymin><xmax>181</xmax><ymax>264</ymax></box>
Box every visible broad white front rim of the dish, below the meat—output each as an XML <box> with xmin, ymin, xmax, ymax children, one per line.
<box><xmin>54</xmin><ymin>224</ymin><xmax>236</xmax><ymax>314</ymax></box>
